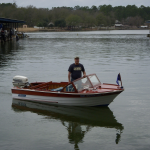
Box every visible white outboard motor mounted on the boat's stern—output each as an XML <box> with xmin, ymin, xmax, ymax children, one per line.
<box><xmin>12</xmin><ymin>75</ymin><xmax>29</xmax><ymax>87</ymax></box>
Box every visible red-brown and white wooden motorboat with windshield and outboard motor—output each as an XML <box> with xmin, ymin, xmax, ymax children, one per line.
<box><xmin>12</xmin><ymin>74</ymin><xmax>124</xmax><ymax>106</ymax></box>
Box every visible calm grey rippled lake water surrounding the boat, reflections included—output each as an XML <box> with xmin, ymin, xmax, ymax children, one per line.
<box><xmin>0</xmin><ymin>30</ymin><xmax>150</xmax><ymax>150</ymax></box>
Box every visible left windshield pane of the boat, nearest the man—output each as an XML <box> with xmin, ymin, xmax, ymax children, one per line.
<box><xmin>73</xmin><ymin>77</ymin><xmax>93</xmax><ymax>91</ymax></box>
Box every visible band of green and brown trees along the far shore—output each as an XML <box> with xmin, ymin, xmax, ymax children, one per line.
<box><xmin>0</xmin><ymin>3</ymin><xmax>150</xmax><ymax>27</ymax></box>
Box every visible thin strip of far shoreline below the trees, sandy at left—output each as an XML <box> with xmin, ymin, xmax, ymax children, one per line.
<box><xmin>18</xmin><ymin>27</ymin><xmax>149</xmax><ymax>32</ymax></box>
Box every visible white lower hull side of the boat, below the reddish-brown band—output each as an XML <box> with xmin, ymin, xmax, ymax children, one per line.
<box><xmin>12</xmin><ymin>93</ymin><xmax>119</xmax><ymax>106</ymax></box>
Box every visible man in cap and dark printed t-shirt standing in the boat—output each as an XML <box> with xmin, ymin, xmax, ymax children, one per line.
<box><xmin>68</xmin><ymin>57</ymin><xmax>86</xmax><ymax>82</ymax></box>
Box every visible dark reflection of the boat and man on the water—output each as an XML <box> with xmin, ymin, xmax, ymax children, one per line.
<box><xmin>12</xmin><ymin>99</ymin><xmax>124</xmax><ymax>149</ymax></box>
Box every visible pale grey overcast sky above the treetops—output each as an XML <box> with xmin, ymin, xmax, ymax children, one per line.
<box><xmin>0</xmin><ymin>0</ymin><xmax>150</xmax><ymax>8</ymax></box>
